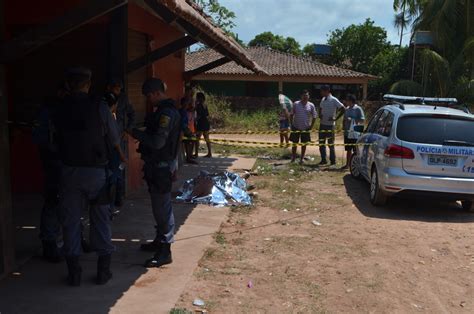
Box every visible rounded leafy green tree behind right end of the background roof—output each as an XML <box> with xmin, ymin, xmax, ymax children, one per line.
<box><xmin>328</xmin><ymin>19</ymin><xmax>390</xmax><ymax>73</ymax></box>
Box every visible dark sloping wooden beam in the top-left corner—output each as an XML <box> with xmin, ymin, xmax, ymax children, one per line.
<box><xmin>0</xmin><ymin>0</ymin><xmax>128</xmax><ymax>63</ymax></box>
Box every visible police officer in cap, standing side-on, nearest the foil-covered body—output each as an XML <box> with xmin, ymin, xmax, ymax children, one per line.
<box><xmin>131</xmin><ymin>78</ymin><xmax>181</xmax><ymax>267</ymax></box>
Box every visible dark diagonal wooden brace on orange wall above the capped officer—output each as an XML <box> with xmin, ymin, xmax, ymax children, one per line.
<box><xmin>127</xmin><ymin>36</ymin><xmax>198</xmax><ymax>73</ymax></box>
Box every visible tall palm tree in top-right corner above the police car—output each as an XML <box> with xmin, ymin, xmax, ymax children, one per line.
<box><xmin>390</xmin><ymin>0</ymin><xmax>474</xmax><ymax>104</ymax></box>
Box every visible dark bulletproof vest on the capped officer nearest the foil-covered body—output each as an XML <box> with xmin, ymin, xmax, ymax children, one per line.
<box><xmin>143</xmin><ymin>99</ymin><xmax>181</xmax><ymax>162</ymax></box>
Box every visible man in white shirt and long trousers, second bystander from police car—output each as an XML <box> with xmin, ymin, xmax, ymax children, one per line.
<box><xmin>319</xmin><ymin>85</ymin><xmax>346</xmax><ymax>167</ymax></box>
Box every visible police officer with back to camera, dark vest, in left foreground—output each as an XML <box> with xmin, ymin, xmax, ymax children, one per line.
<box><xmin>54</xmin><ymin>68</ymin><xmax>125</xmax><ymax>286</ymax></box>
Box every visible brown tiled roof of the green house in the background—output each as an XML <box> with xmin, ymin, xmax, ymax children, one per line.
<box><xmin>186</xmin><ymin>47</ymin><xmax>375</xmax><ymax>79</ymax></box>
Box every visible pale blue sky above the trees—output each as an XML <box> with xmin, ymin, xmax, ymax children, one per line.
<box><xmin>219</xmin><ymin>0</ymin><xmax>409</xmax><ymax>47</ymax></box>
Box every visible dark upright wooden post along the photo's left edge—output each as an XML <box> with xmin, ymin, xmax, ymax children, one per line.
<box><xmin>0</xmin><ymin>1</ymin><xmax>15</xmax><ymax>277</ymax></box>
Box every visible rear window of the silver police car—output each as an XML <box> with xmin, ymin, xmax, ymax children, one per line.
<box><xmin>397</xmin><ymin>115</ymin><xmax>474</xmax><ymax>146</ymax></box>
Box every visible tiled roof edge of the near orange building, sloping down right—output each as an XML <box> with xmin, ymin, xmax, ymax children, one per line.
<box><xmin>157</xmin><ymin>0</ymin><xmax>265</xmax><ymax>73</ymax></box>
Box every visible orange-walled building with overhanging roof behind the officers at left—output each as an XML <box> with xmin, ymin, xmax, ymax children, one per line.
<box><xmin>0</xmin><ymin>0</ymin><xmax>264</xmax><ymax>277</ymax></box>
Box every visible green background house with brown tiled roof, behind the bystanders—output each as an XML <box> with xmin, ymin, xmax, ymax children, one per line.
<box><xmin>186</xmin><ymin>47</ymin><xmax>376</xmax><ymax>104</ymax></box>
